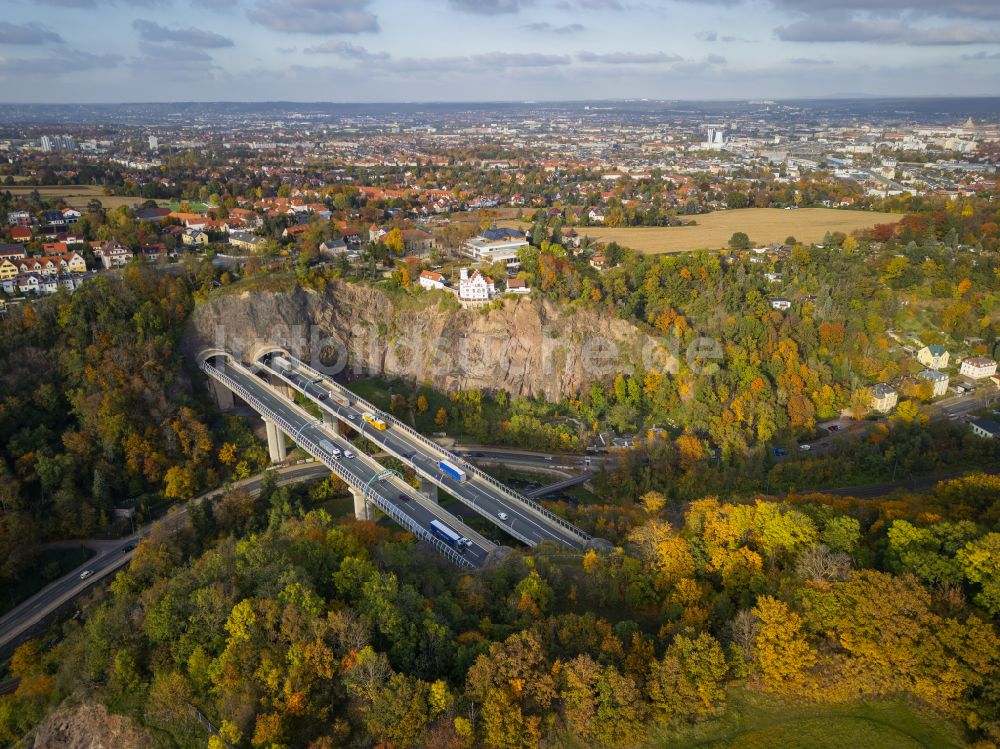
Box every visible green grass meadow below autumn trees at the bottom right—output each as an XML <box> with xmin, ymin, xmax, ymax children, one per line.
<box><xmin>647</xmin><ymin>688</ymin><xmax>964</xmax><ymax>749</ymax></box>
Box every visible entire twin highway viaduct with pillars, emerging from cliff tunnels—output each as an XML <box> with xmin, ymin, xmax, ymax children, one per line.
<box><xmin>199</xmin><ymin>346</ymin><xmax>606</xmax><ymax>567</ymax></box>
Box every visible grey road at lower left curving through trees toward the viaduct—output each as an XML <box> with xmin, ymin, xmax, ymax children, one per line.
<box><xmin>0</xmin><ymin>464</ymin><xmax>329</xmax><ymax>649</ymax></box>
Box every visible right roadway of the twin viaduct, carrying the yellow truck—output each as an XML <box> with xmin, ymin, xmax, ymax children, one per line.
<box><xmin>256</xmin><ymin>357</ymin><xmax>590</xmax><ymax>548</ymax></box>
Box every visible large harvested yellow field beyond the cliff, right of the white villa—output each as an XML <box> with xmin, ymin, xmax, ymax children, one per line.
<box><xmin>508</xmin><ymin>208</ymin><xmax>902</xmax><ymax>254</ymax></box>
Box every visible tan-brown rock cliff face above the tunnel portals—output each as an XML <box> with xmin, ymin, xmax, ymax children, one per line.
<box><xmin>185</xmin><ymin>282</ymin><xmax>676</xmax><ymax>400</ymax></box>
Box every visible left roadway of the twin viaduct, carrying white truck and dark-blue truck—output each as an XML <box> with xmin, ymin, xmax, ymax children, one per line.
<box><xmin>210</xmin><ymin>360</ymin><xmax>496</xmax><ymax>567</ymax></box>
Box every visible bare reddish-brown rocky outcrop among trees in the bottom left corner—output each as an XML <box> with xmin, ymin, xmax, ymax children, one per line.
<box><xmin>24</xmin><ymin>703</ymin><xmax>154</xmax><ymax>749</ymax></box>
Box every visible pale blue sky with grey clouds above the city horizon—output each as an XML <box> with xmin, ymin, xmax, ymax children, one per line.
<box><xmin>0</xmin><ymin>0</ymin><xmax>1000</xmax><ymax>102</ymax></box>
